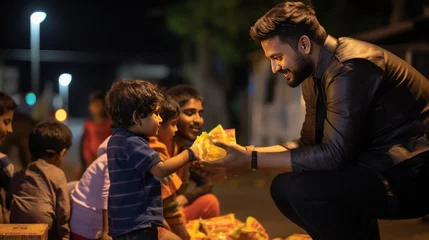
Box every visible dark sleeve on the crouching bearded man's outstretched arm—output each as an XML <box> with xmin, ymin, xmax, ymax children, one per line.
<box><xmin>291</xmin><ymin>59</ymin><xmax>383</xmax><ymax>172</ymax></box>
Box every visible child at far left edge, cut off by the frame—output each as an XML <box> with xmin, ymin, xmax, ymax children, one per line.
<box><xmin>0</xmin><ymin>92</ymin><xmax>18</xmax><ymax>223</ymax></box>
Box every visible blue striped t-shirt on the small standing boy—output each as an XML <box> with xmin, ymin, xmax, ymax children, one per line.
<box><xmin>107</xmin><ymin>128</ymin><xmax>163</xmax><ymax>237</ymax></box>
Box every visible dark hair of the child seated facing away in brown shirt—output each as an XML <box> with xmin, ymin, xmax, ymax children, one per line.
<box><xmin>28</xmin><ymin>120</ymin><xmax>73</xmax><ymax>160</ymax></box>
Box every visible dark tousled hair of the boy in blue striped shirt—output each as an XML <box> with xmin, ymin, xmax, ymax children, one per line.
<box><xmin>106</xmin><ymin>80</ymin><xmax>163</xmax><ymax>128</ymax></box>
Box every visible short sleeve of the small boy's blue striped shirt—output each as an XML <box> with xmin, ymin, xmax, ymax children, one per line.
<box><xmin>128</xmin><ymin>138</ymin><xmax>161</xmax><ymax>173</ymax></box>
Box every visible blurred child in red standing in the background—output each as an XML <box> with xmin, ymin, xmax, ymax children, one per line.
<box><xmin>81</xmin><ymin>91</ymin><xmax>112</xmax><ymax>169</ymax></box>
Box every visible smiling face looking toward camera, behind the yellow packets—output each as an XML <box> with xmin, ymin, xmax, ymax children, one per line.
<box><xmin>177</xmin><ymin>98</ymin><xmax>204</xmax><ymax>141</ymax></box>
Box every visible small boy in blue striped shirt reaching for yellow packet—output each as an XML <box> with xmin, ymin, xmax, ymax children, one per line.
<box><xmin>107</xmin><ymin>80</ymin><xmax>198</xmax><ymax>239</ymax></box>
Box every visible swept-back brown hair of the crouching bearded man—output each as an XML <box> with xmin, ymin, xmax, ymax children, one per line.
<box><xmin>250</xmin><ymin>1</ymin><xmax>328</xmax><ymax>49</ymax></box>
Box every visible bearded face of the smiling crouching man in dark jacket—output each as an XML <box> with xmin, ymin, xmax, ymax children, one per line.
<box><xmin>261</xmin><ymin>36</ymin><xmax>312</xmax><ymax>87</ymax></box>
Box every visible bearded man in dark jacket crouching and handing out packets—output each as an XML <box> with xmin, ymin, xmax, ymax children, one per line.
<box><xmin>200</xmin><ymin>2</ymin><xmax>429</xmax><ymax>240</ymax></box>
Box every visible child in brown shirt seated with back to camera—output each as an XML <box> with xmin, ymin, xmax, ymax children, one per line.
<box><xmin>10</xmin><ymin>121</ymin><xmax>72</xmax><ymax>239</ymax></box>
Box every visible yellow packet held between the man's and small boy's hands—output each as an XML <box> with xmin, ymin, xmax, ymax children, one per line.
<box><xmin>193</xmin><ymin>125</ymin><xmax>236</xmax><ymax>161</ymax></box>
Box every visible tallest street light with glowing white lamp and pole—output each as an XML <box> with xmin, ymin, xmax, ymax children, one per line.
<box><xmin>30</xmin><ymin>12</ymin><xmax>46</xmax><ymax>95</ymax></box>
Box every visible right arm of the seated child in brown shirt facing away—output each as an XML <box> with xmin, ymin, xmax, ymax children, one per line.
<box><xmin>55</xmin><ymin>173</ymin><xmax>70</xmax><ymax>240</ymax></box>
